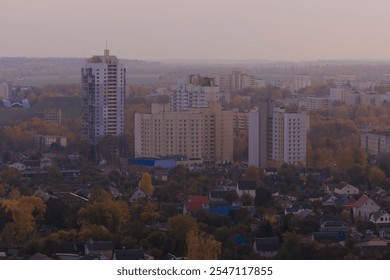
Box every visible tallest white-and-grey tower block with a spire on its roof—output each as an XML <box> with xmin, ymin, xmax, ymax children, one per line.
<box><xmin>81</xmin><ymin>50</ymin><xmax>126</xmax><ymax>144</ymax></box>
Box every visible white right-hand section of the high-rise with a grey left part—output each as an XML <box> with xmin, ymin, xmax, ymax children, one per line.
<box><xmin>272</xmin><ymin>108</ymin><xmax>309</xmax><ymax>165</ymax></box>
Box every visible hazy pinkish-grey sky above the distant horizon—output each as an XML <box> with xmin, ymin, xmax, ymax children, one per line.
<box><xmin>0</xmin><ymin>0</ymin><xmax>390</xmax><ymax>61</ymax></box>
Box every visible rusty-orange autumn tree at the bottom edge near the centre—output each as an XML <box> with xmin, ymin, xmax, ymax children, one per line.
<box><xmin>186</xmin><ymin>228</ymin><xmax>221</xmax><ymax>260</ymax></box>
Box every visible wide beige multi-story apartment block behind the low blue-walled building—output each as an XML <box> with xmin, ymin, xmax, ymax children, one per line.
<box><xmin>134</xmin><ymin>101</ymin><xmax>233</xmax><ymax>163</ymax></box>
